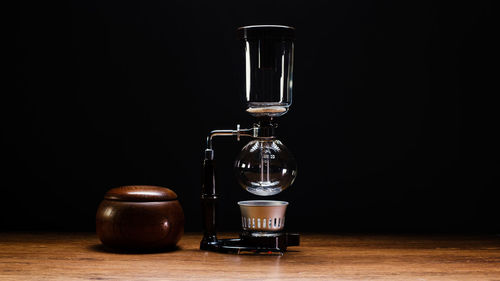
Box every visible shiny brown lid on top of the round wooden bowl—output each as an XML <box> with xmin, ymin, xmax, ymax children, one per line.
<box><xmin>104</xmin><ymin>185</ymin><xmax>177</xmax><ymax>202</ymax></box>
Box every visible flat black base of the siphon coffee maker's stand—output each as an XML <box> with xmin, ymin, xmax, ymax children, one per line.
<box><xmin>200</xmin><ymin>232</ymin><xmax>300</xmax><ymax>254</ymax></box>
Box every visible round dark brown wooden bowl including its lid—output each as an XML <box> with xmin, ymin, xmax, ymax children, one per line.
<box><xmin>96</xmin><ymin>185</ymin><xmax>184</xmax><ymax>250</ymax></box>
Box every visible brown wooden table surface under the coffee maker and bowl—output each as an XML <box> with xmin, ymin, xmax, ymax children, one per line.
<box><xmin>0</xmin><ymin>233</ymin><xmax>500</xmax><ymax>280</ymax></box>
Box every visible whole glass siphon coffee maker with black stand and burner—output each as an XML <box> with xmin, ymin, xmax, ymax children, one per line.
<box><xmin>200</xmin><ymin>25</ymin><xmax>299</xmax><ymax>253</ymax></box>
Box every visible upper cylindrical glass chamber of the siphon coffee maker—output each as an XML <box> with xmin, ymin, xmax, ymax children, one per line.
<box><xmin>238</xmin><ymin>25</ymin><xmax>295</xmax><ymax>117</ymax></box>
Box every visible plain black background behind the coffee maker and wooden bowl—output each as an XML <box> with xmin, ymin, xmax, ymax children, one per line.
<box><xmin>5</xmin><ymin>0</ymin><xmax>500</xmax><ymax>232</ymax></box>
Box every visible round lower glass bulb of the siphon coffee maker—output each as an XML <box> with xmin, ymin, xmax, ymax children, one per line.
<box><xmin>234</xmin><ymin>139</ymin><xmax>297</xmax><ymax>196</ymax></box>
